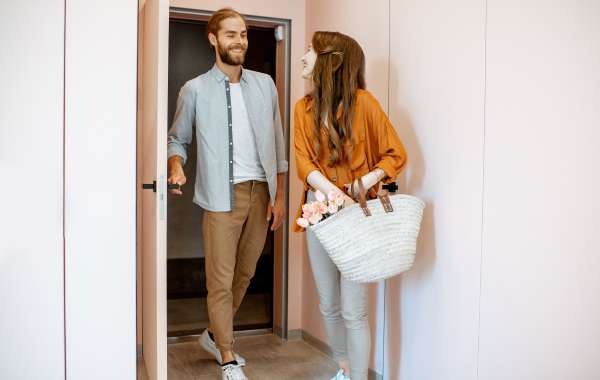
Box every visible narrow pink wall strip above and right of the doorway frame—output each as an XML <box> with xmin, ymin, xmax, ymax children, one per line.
<box><xmin>171</xmin><ymin>0</ymin><xmax>306</xmax><ymax>330</ymax></box>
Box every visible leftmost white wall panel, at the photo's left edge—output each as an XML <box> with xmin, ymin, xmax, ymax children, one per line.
<box><xmin>0</xmin><ymin>0</ymin><xmax>65</xmax><ymax>380</ymax></box>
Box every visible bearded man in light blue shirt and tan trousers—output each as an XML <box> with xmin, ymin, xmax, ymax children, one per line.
<box><xmin>168</xmin><ymin>8</ymin><xmax>288</xmax><ymax>380</ymax></box>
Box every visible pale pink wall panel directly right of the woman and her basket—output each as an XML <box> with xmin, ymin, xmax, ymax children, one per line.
<box><xmin>386</xmin><ymin>0</ymin><xmax>485</xmax><ymax>380</ymax></box>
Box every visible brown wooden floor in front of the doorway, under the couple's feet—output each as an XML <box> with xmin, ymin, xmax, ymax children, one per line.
<box><xmin>138</xmin><ymin>335</ymin><xmax>337</xmax><ymax>380</ymax></box>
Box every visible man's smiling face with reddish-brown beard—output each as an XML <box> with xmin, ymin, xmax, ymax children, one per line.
<box><xmin>209</xmin><ymin>17</ymin><xmax>248</xmax><ymax>66</ymax></box>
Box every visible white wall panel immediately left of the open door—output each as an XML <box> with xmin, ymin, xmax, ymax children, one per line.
<box><xmin>65</xmin><ymin>0</ymin><xmax>137</xmax><ymax>379</ymax></box>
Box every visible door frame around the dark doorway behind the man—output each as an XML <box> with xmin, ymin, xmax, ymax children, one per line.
<box><xmin>165</xmin><ymin>7</ymin><xmax>291</xmax><ymax>343</ymax></box>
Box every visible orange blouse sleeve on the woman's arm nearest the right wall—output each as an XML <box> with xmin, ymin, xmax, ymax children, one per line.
<box><xmin>370</xmin><ymin>93</ymin><xmax>407</xmax><ymax>183</ymax></box>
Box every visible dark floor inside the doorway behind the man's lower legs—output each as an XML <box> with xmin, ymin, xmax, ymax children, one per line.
<box><xmin>167</xmin><ymin>294</ymin><xmax>272</xmax><ymax>336</ymax></box>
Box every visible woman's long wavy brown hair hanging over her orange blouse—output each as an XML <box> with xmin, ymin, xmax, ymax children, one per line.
<box><xmin>309</xmin><ymin>32</ymin><xmax>365</xmax><ymax>166</ymax></box>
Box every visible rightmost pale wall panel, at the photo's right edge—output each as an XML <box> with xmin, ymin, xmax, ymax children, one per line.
<box><xmin>479</xmin><ymin>0</ymin><xmax>600</xmax><ymax>380</ymax></box>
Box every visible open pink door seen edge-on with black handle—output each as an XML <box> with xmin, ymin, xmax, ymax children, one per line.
<box><xmin>138</xmin><ymin>0</ymin><xmax>169</xmax><ymax>380</ymax></box>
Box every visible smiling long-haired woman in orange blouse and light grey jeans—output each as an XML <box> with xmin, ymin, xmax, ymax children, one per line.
<box><xmin>294</xmin><ymin>32</ymin><xmax>406</xmax><ymax>380</ymax></box>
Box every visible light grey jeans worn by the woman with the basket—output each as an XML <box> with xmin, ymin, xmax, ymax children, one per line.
<box><xmin>306</xmin><ymin>191</ymin><xmax>371</xmax><ymax>380</ymax></box>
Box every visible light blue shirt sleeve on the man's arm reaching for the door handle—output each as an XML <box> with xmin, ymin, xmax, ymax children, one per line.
<box><xmin>167</xmin><ymin>82</ymin><xmax>196</xmax><ymax>164</ymax></box>
